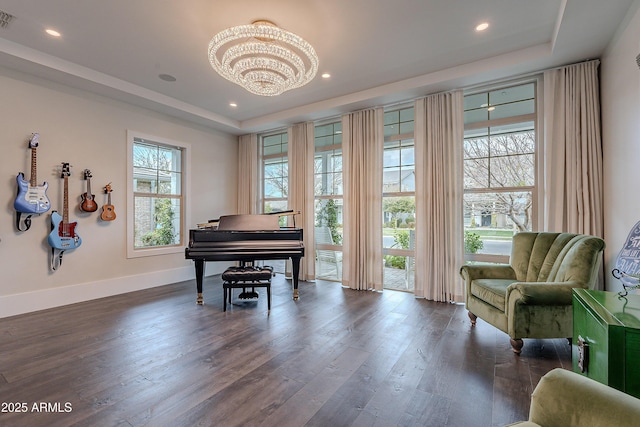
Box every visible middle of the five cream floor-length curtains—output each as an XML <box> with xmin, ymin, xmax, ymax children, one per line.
<box><xmin>342</xmin><ymin>108</ymin><xmax>384</xmax><ymax>291</ymax></box>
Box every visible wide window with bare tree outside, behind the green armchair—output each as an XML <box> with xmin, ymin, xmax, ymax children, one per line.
<box><xmin>464</xmin><ymin>82</ymin><xmax>537</xmax><ymax>262</ymax></box>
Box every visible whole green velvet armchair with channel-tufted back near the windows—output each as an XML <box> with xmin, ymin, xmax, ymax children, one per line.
<box><xmin>460</xmin><ymin>232</ymin><xmax>605</xmax><ymax>354</ymax></box>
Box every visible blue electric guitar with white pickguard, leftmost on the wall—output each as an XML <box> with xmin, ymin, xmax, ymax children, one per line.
<box><xmin>13</xmin><ymin>133</ymin><xmax>51</xmax><ymax>214</ymax></box>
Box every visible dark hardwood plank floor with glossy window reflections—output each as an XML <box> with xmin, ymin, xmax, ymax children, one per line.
<box><xmin>0</xmin><ymin>275</ymin><xmax>571</xmax><ymax>427</ymax></box>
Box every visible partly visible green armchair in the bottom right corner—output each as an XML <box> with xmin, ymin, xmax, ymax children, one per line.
<box><xmin>509</xmin><ymin>368</ymin><xmax>640</xmax><ymax>427</ymax></box>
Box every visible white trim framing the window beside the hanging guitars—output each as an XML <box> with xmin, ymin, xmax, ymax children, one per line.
<box><xmin>126</xmin><ymin>130</ymin><xmax>191</xmax><ymax>258</ymax></box>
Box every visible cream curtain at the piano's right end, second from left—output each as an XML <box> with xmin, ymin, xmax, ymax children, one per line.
<box><xmin>287</xmin><ymin>122</ymin><xmax>316</xmax><ymax>280</ymax></box>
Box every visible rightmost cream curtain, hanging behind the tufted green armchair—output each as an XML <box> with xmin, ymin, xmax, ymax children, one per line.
<box><xmin>543</xmin><ymin>60</ymin><xmax>604</xmax><ymax>237</ymax></box>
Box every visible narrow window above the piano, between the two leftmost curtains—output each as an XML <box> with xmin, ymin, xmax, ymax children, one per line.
<box><xmin>261</xmin><ymin>132</ymin><xmax>289</xmax><ymax>219</ymax></box>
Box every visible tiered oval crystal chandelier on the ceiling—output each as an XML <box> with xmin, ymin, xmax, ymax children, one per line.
<box><xmin>209</xmin><ymin>21</ymin><xmax>318</xmax><ymax>96</ymax></box>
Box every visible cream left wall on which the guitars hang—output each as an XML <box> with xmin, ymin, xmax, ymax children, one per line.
<box><xmin>0</xmin><ymin>69</ymin><xmax>237</xmax><ymax>317</ymax></box>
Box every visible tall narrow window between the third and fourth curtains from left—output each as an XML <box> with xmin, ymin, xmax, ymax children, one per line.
<box><xmin>382</xmin><ymin>107</ymin><xmax>416</xmax><ymax>291</ymax></box>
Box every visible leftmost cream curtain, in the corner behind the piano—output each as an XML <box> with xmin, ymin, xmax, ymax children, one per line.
<box><xmin>237</xmin><ymin>134</ymin><xmax>259</xmax><ymax>214</ymax></box>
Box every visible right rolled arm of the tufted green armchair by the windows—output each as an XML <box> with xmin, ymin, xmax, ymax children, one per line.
<box><xmin>506</xmin><ymin>281</ymin><xmax>587</xmax><ymax>307</ymax></box>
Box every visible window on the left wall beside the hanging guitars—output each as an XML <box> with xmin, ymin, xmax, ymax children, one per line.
<box><xmin>127</xmin><ymin>132</ymin><xmax>186</xmax><ymax>258</ymax></box>
